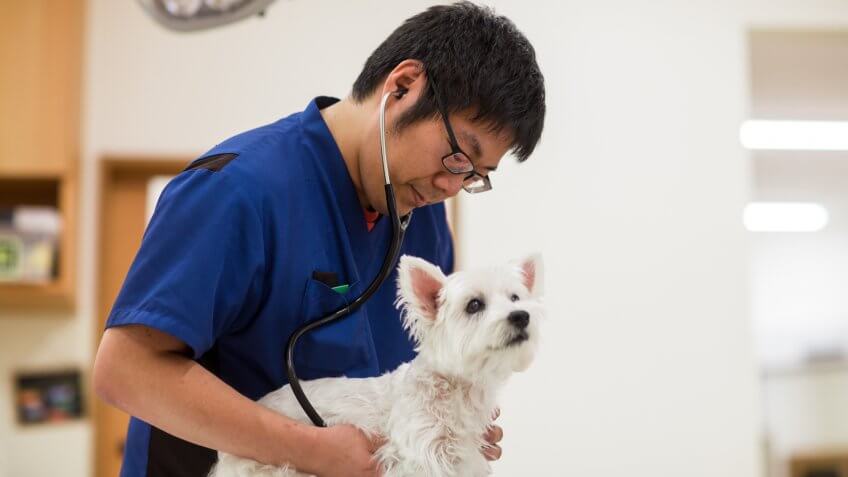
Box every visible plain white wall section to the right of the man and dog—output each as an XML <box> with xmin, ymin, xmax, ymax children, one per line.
<box><xmin>463</xmin><ymin>1</ymin><xmax>760</xmax><ymax>477</ymax></box>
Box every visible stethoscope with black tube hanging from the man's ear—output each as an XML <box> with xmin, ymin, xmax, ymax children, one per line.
<box><xmin>286</xmin><ymin>89</ymin><xmax>412</xmax><ymax>427</ymax></box>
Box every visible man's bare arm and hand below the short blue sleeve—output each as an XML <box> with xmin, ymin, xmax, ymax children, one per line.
<box><xmin>94</xmin><ymin>325</ymin><xmax>377</xmax><ymax>475</ymax></box>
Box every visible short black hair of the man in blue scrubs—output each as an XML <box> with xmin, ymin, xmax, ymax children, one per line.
<box><xmin>352</xmin><ymin>2</ymin><xmax>545</xmax><ymax>162</ymax></box>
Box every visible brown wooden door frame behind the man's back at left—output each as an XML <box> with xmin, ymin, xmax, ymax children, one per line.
<box><xmin>94</xmin><ymin>156</ymin><xmax>193</xmax><ymax>477</ymax></box>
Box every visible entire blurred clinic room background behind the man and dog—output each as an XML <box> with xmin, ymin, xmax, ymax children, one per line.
<box><xmin>0</xmin><ymin>0</ymin><xmax>848</xmax><ymax>477</ymax></box>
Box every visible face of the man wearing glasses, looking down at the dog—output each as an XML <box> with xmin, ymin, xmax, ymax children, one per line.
<box><xmin>360</xmin><ymin>104</ymin><xmax>510</xmax><ymax>215</ymax></box>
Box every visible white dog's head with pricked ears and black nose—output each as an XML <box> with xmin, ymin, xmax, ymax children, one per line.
<box><xmin>398</xmin><ymin>255</ymin><xmax>543</xmax><ymax>377</ymax></box>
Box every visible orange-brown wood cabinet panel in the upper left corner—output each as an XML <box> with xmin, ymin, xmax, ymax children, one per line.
<box><xmin>0</xmin><ymin>0</ymin><xmax>84</xmax><ymax>175</ymax></box>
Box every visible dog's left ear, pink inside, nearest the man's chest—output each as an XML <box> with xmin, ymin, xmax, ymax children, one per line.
<box><xmin>398</xmin><ymin>255</ymin><xmax>445</xmax><ymax>320</ymax></box>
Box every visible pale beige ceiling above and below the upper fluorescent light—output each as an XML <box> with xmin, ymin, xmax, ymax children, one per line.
<box><xmin>748</xmin><ymin>30</ymin><xmax>848</xmax><ymax>192</ymax></box>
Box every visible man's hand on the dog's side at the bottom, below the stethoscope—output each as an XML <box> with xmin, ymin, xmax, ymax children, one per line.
<box><xmin>304</xmin><ymin>424</ymin><xmax>385</xmax><ymax>477</ymax></box>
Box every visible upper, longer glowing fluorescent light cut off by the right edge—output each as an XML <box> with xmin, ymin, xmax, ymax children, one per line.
<box><xmin>739</xmin><ymin>119</ymin><xmax>848</xmax><ymax>151</ymax></box>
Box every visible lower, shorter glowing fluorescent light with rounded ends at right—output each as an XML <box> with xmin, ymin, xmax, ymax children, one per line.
<box><xmin>742</xmin><ymin>202</ymin><xmax>830</xmax><ymax>232</ymax></box>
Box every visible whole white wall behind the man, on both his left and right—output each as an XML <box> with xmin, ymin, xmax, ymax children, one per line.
<box><xmin>0</xmin><ymin>0</ymin><xmax>837</xmax><ymax>477</ymax></box>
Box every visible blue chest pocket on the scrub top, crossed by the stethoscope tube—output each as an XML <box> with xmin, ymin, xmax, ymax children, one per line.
<box><xmin>295</xmin><ymin>279</ymin><xmax>376</xmax><ymax>379</ymax></box>
